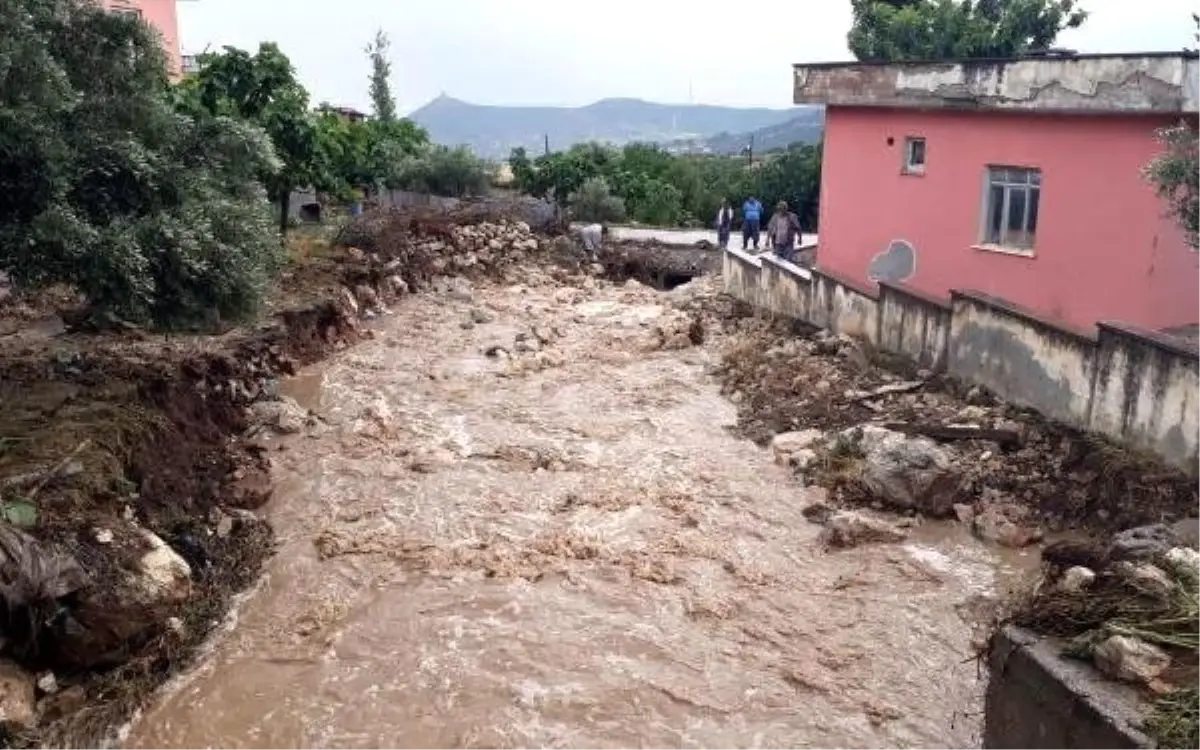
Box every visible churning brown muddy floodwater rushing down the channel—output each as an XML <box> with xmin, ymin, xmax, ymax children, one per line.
<box><xmin>126</xmin><ymin>274</ymin><xmax>1022</xmax><ymax>750</ymax></box>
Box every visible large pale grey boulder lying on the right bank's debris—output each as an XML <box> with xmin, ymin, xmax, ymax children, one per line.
<box><xmin>842</xmin><ymin>425</ymin><xmax>962</xmax><ymax>517</ymax></box>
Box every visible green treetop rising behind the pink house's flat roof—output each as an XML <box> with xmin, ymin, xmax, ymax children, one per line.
<box><xmin>847</xmin><ymin>0</ymin><xmax>1087</xmax><ymax>61</ymax></box>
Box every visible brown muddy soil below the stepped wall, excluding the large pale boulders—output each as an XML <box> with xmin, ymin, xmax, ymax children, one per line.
<box><xmin>720</xmin><ymin>317</ymin><xmax>1200</xmax><ymax>534</ymax></box>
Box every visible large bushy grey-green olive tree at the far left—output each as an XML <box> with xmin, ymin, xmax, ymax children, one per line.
<box><xmin>0</xmin><ymin>0</ymin><xmax>280</xmax><ymax>325</ymax></box>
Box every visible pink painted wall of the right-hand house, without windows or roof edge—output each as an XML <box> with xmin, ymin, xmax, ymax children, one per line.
<box><xmin>818</xmin><ymin>107</ymin><xmax>1200</xmax><ymax>329</ymax></box>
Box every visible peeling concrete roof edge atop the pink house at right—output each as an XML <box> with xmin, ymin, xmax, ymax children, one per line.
<box><xmin>793</xmin><ymin>53</ymin><xmax>1200</xmax><ymax>114</ymax></box>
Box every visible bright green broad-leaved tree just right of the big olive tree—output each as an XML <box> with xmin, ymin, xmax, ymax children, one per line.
<box><xmin>182</xmin><ymin>42</ymin><xmax>328</xmax><ymax>232</ymax></box>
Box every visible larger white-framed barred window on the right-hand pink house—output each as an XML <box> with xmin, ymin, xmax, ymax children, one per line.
<box><xmin>979</xmin><ymin>166</ymin><xmax>1042</xmax><ymax>254</ymax></box>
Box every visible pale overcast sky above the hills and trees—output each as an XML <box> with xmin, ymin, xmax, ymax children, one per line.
<box><xmin>179</xmin><ymin>0</ymin><xmax>1200</xmax><ymax>112</ymax></box>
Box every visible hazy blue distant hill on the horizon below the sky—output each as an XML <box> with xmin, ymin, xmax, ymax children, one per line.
<box><xmin>409</xmin><ymin>96</ymin><xmax>820</xmax><ymax>158</ymax></box>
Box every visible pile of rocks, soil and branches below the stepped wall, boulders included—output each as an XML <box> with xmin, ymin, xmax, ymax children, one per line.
<box><xmin>718</xmin><ymin>318</ymin><xmax>1200</xmax><ymax>546</ymax></box>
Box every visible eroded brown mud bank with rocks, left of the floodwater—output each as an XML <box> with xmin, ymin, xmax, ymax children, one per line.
<box><xmin>0</xmin><ymin>294</ymin><xmax>354</xmax><ymax>746</ymax></box>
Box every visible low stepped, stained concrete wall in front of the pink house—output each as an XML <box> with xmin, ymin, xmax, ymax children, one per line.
<box><xmin>724</xmin><ymin>250</ymin><xmax>1200</xmax><ymax>474</ymax></box>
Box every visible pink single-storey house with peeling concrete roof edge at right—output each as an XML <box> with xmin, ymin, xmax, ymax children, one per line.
<box><xmin>794</xmin><ymin>54</ymin><xmax>1200</xmax><ymax>331</ymax></box>
